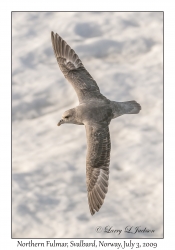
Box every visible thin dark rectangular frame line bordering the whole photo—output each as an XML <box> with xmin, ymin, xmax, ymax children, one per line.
<box><xmin>11</xmin><ymin>11</ymin><xmax>165</xmax><ymax>240</ymax></box>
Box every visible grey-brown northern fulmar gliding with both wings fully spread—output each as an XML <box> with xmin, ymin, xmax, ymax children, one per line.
<box><xmin>51</xmin><ymin>31</ymin><xmax>141</xmax><ymax>215</ymax></box>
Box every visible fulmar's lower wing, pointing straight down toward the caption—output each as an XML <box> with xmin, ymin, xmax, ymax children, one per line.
<box><xmin>85</xmin><ymin>124</ymin><xmax>111</xmax><ymax>215</ymax></box>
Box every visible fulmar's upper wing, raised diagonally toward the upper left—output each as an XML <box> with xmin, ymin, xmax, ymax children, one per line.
<box><xmin>51</xmin><ymin>31</ymin><xmax>108</xmax><ymax>103</ymax></box>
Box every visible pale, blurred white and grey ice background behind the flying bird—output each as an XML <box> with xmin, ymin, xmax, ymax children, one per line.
<box><xmin>12</xmin><ymin>12</ymin><xmax>163</xmax><ymax>238</ymax></box>
